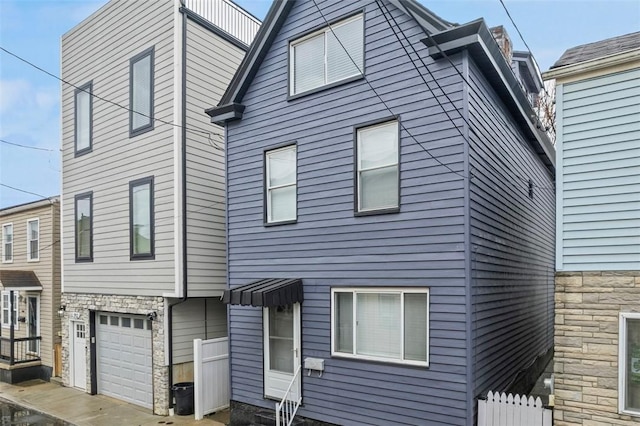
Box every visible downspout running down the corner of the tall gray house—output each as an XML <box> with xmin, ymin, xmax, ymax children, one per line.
<box><xmin>167</xmin><ymin>0</ymin><xmax>188</xmax><ymax>410</ymax></box>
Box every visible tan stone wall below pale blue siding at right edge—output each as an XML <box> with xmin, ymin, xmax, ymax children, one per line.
<box><xmin>554</xmin><ymin>271</ymin><xmax>640</xmax><ymax>426</ymax></box>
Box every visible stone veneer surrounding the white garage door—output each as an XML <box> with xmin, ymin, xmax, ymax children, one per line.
<box><xmin>62</xmin><ymin>293</ymin><xmax>169</xmax><ymax>415</ymax></box>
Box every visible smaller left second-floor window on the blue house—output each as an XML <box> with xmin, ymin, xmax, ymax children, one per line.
<box><xmin>265</xmin><ymin>145</ymin><xmax>297</xmax><ymax>223</ymax></box>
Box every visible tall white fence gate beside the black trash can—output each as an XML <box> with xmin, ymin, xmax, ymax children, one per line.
<box><xmin>193</xmin><ymin>337</ymin><xmax>229</xmax><ymax>420</ymax></box>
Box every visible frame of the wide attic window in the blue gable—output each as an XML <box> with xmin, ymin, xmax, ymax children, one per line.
<box><xmin>287</xmin><ymin>9</ymin><xmax>367</xmax><ymax>101</ymax></box>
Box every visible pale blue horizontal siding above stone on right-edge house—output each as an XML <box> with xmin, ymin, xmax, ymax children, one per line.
<box><xmin>557</xmin><ymin>68</ymin><xmax>640</xmax><ymax>271</ymax></box>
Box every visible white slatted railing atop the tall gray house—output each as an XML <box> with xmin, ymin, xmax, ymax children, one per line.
<box><xmin>184</xmin><ymin>0</ymin><xmax>260</xmax><ymax>46</ymax></box>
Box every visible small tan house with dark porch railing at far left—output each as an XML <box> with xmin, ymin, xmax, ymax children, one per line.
<box><xmin>0</xmin><ymin>197</ymin><xmax>61</xmax><ymax>383</ymax></box>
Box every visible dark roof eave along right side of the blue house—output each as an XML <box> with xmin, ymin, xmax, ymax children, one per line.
<box><xmin>422</xmin><ymin>18</ymin><xmax>556</xmax><ymax>174</ymax></box>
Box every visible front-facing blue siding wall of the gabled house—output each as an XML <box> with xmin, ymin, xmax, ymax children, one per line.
<box><xmin>227</xmin><ymin>0</ymin><xmax>468</xmax><ymax>425</ymax></box>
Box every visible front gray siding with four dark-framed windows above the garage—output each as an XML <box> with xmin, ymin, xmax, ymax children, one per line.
<box><xmin>61</xmin><ymin>0</ymin><xmax>176</xmax><ymax>296</ymax></box>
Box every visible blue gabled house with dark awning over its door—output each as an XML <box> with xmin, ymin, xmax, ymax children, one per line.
<box><xmin>207</xmin><ymin>0</ymin><xmax>555</xmax><ymax>425</ymax></box>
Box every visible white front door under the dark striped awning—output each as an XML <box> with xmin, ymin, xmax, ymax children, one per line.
<box><xmin>263</xmin><ymin>303</ymin><xmax>302</xmax><ymax>399</ymax></box>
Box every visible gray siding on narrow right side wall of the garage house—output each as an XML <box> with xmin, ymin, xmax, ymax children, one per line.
<box><xmin>185</xmin><ymin>19</ymin><xmax>244</xmax><ymax>297</ymax></box>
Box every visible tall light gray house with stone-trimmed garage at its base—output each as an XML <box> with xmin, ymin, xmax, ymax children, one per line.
<box><xmin>60</xmin><ymin>0</ymin><xmax>259</xmax><ymax>414</ymax></box>
